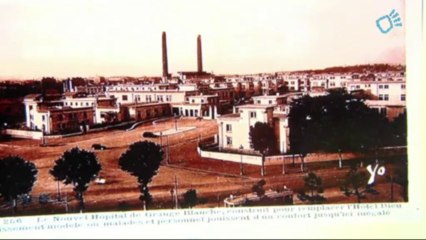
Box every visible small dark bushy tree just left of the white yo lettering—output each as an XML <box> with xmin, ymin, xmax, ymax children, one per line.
<box><xmin>341</xmin><ymin>165</ymin><xmax>367</xmax><ymax>203</ymax></box>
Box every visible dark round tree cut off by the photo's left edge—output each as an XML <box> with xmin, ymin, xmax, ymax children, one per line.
<box><xmin>0</xmin><ymin>156</ymin><xmax>37</xmax><ymax>213</ymax></box>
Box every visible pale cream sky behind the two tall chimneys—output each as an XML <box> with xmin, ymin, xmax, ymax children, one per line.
<box><xmin>0</xmin><ymin>0</ymin><xmax>405</xmax><ymax>78</ymax></box>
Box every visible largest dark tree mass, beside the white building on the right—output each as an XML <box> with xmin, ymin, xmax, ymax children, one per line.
<box><xmin>289</xmin><ymin>89</ymin><xmax>390</xmax><ymax>170</ymax></box>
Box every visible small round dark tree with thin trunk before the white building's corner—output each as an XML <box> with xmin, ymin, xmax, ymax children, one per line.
<box><xmin>249</xmin><ymin>122</ymin><xmax>277</xmax><ymax>176</ymax></box>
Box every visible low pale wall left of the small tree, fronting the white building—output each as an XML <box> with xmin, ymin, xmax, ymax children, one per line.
<box><xmin>198</xmin><ymin>148</ymin><xmax>262</xmax><ymax>166</ymax></box>
